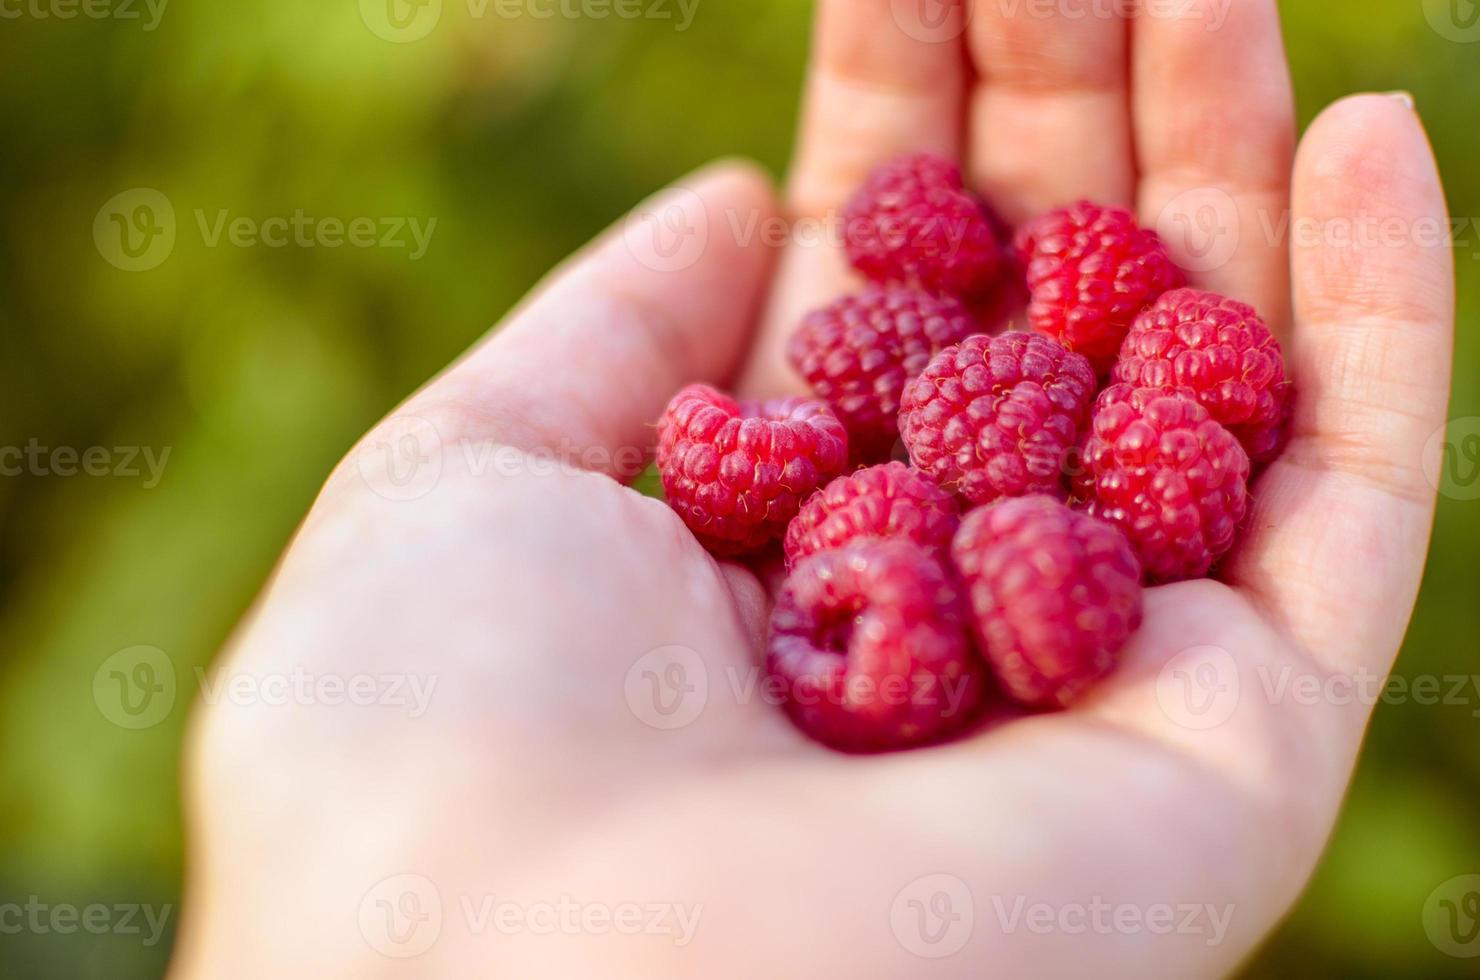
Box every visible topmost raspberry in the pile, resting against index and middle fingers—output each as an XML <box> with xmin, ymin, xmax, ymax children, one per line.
<box><xmin>842</xmin><ymin>154</ymin><xmax>1002</xmax><ymax>298</ymax></box>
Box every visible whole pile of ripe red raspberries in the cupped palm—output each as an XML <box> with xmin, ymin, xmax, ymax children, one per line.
<box><xmin>657</xmin><ymin>154</ymin><xmax>1291</xmax><ymax>752</ymax></box>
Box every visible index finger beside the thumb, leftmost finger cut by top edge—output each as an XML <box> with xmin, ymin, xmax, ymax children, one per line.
<box><xmin>740</xmin><ymin>0</ymin><xmax>966</xmax><ymax>397</ymax></box>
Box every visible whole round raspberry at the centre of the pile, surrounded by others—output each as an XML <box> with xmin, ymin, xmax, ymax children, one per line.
<box><xmin>900</xmin><ymin>333</ymin><xmax>1095</xmax><ymax>503</ymax></box>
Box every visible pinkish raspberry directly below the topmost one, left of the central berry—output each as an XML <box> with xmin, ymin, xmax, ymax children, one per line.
<box><xmin>787</xmin><ymin>286</ymin><xmax>974</xmax><ymax>460</ymax></box>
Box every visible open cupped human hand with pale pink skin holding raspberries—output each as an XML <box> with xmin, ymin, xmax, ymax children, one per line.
<box><xmin>172</xmin><ymin>0</ymin><xmax>1453</xmax><ymax>980</ymax></box>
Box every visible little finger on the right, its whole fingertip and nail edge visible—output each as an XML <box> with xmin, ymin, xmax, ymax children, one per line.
<box><xmin>1228</xmin><ymin>95</ymin><xmax>1455</xmax><ymax>680</ymax></box>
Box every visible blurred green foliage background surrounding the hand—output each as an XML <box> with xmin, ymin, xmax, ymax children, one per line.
<box><xmin>0</xmin><ymin>0</ymin><xmax>1480</xmax><ymax>979</ymax></box>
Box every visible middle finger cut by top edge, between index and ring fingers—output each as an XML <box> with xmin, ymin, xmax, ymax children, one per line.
<box><xmin>968</xmin><ymin>0</ymin><xmax>1135</xmax><ymax>224</ymax></box>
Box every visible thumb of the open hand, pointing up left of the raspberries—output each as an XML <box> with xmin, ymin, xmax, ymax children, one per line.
<box><xmin>378</xmin><ymin>164</ymin><xmax>776</xmax><ymax>477</ymax></box>
